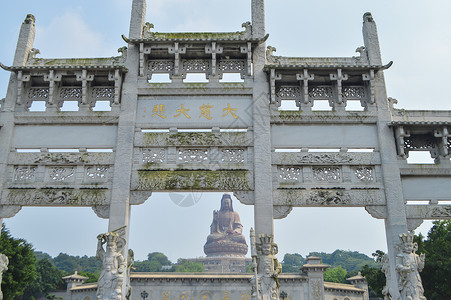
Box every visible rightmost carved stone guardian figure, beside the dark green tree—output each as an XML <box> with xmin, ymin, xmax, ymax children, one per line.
<box><xmin>396</xmin><ymin>231</ymin><xmax>426</xmax><ymax>300</ymax></box>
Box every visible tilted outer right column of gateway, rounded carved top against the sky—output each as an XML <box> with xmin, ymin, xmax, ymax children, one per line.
<box><xmin>363</xmin><ymin>13</ymin><xmax>407</xmax><ymax>299</ymax></box>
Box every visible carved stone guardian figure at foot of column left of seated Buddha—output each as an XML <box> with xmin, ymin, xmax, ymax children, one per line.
<box><xmin>96</xmin><ymin>232</ymin><xmax>127</xmax><ymax>300</ymax></box>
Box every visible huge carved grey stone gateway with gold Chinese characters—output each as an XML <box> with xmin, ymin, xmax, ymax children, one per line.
<box><xmin>0</xmin><ymin>0</ymin><xmax>451</xmax><ymax>300</ymax></box>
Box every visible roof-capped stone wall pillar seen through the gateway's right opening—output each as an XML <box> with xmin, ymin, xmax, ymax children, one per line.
<box><xmin>301</xmin><ymin>256</ymin><xmax>329</xmax><ymax>300</ymax></box>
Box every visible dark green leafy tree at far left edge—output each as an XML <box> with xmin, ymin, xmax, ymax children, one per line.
<box><xmin>0</xmin><ymin>226</ymin><xmax>37</xmax><ymax>300</ymax></box>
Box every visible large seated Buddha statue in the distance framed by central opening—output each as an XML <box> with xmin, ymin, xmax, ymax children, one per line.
<box><xmin>204</xmin><ymin>194</ymin><xmax>247</xmax><ymax>256</ymax></box>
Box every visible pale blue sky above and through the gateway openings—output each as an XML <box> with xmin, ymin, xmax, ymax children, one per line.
<box><xmin>0</xmin><ymin>0</ymin><xmax>451</xmax><ymax>260</ymax></box>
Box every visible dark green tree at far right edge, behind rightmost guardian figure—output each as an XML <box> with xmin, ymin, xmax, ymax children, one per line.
<box><xmin>416</xmin><ymin>220</ymin><xmax>451</xmax><ymax>300</ymax></box>
